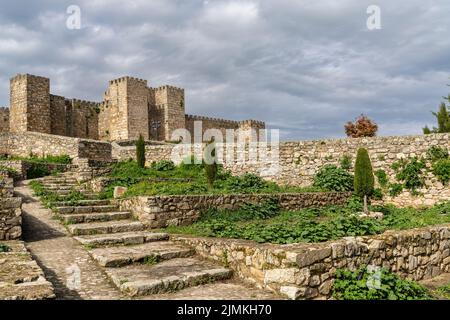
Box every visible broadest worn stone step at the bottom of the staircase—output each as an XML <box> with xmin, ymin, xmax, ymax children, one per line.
<box><xmin>106</xmin><ymin>258</ymin><xmax>232</xmax><ymax>296</ymax></box>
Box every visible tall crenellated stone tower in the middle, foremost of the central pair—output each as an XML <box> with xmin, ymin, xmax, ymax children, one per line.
<box><xmin>98</xmin><ymin>77</ymin><xmax>150</xmax><ymax>140</ymax></box>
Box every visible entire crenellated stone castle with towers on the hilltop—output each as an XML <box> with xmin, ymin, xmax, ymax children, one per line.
<box><xmin>0</xmin><ymin>74</ymin><xmax>265</xmax><ymax>141</ymax></box>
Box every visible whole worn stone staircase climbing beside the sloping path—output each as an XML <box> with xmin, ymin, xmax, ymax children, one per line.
<box><xmin>34</xmin><ymin>172</ymin><xmax>272</xmax><ymax>299</ymax></box>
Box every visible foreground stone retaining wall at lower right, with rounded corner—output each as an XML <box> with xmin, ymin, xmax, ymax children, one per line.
<box><xmin>172</xmin><ymin>224</ymin><xmax>450</xmax><ymax>299</ymax></box>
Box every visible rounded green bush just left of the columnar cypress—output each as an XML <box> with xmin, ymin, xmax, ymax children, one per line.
<box><xmin>313</xmin><ymin>165</ymin><xmax>353</xmax><ymax>191</ymax></box>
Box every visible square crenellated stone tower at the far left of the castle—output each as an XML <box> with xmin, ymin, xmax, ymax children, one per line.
<box><xmin>9</xmin><ymin>74</ymin><xmax>51</xmax><ymax>133</ymax></box>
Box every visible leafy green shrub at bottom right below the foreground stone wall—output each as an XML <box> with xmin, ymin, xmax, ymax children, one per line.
<box><xmin>332</xmin><ymin>267</ymin><xmax>431</xmax><ymax>300</ymax></box>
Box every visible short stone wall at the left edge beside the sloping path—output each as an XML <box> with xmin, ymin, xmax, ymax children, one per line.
<box><xmin>0</xmin><ymin>179</ymin><xmax>22</xmax><ymax>240</ymax></box>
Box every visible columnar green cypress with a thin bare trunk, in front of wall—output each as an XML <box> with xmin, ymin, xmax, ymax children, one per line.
<box><xmin>354</xmin><ymin>148</ymin><xmax>375</xmax><ymax>214</ymax></box>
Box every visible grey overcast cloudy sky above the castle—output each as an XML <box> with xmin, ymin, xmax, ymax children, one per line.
<box><xmin>0</xmin><ymin>0</ymin><xmax>450</xmax><ymax>139</ymax></box>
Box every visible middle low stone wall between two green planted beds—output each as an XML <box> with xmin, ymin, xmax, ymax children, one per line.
<box><xmin>118</xmin><ymin>192</ymin><xmax>351</xmax><ymax>228</ymax></box>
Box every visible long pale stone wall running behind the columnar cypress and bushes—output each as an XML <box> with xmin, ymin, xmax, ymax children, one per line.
<box><xmin>113</xmin><ymin>133</ymin><xmax>450</xmax><ymax>206</ymax></box>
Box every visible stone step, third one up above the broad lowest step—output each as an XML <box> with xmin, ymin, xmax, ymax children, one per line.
<box><xmin>67</xmin><ymin>220</ymin><xmax>145</xmax><ymax>236</ymax></box>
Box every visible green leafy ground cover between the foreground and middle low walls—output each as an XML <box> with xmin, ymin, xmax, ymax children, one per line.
<box><xmin>165</xmin><ymin>199</ymin><xmax>450</xmax><ymax>244</ymax></box>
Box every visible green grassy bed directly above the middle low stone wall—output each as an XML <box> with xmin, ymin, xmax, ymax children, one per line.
<box><xmin>101</xmin><ymin>161</ymin><xmax>322</xmax><ymax>198</ymax></box>
